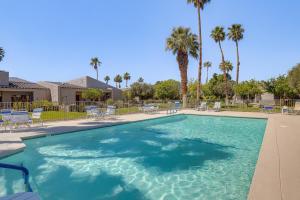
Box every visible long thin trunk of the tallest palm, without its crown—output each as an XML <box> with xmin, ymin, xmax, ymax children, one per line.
<box><xmin>197</xmin><ymin>5</ymin><xmax>202</xmax><ymax>104</ymax></box>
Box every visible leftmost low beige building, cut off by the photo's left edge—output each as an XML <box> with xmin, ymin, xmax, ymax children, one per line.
<box><xmin>0</xmin><ymin>71</ymin><xmax>50</xmax><ymax>103</ymax></box>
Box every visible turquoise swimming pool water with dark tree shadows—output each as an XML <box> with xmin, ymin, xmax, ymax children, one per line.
<box><xmin>0</xmin><ymin>115</ymin><xmax>267</xmax><ymax>200</ymax></box>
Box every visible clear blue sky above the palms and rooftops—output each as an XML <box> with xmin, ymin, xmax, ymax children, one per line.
<box><xmin>0</xmin><ymin>0</ymin><xmax>300</xmax><ymax>83</ymax></box>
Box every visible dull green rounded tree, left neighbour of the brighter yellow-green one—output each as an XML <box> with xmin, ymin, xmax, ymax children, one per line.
<box><xmin>130</xmin><ymin>82</ymin><xmax>154</xmax><ymax>100</ymax></box>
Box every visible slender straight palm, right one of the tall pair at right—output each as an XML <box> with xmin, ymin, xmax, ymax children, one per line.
<box><xmin>227</xmin><ymin>24</ymin><xmax>245</xmax><ymax>84</ymax></box>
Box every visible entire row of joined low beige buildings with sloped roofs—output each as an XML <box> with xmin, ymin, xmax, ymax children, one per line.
<box><xmin>0</xmin><ymin>71</ymin><xmax>122</xmax><ymax>104</ymax></box>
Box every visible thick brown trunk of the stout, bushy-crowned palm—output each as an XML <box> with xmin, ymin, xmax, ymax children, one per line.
<box><xmin>177</xmin><ymin>51</ymin><xmax>189</xmax><ymax>108</ymax></box>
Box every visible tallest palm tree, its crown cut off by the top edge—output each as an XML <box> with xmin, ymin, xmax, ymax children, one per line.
<box><xmin>187</xmin><ymin>0</ymin><xmax>210</xmax><ymax>103</ymax></box>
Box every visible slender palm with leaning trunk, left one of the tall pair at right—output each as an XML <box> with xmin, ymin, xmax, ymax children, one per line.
<box><xmin>210</xmin><ymin>26</ymin><xmax>228</xmax><ymax>104</ymax></box>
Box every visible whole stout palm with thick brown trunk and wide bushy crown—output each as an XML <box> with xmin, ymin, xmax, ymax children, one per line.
<box><xmin>166</xmin><ymin>27</ymin><xmax>199</xmax><ymax>108</ymax></box>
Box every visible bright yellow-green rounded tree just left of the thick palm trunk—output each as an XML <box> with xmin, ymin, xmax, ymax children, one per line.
<box><xmin>154</xmin><ymin>79</ymin><xmax>180</xmax><ymax>100</ymax></box>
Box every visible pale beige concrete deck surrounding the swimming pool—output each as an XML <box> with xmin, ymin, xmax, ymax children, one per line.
<box><xmin>0</xmin><ymin>110</ymin><xmax>300</xmax><ymax>200</ymax></box>
